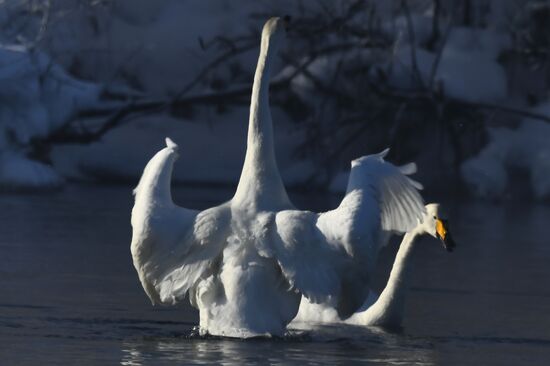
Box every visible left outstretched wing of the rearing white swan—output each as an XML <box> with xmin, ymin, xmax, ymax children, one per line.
<box><xmin>131</xmin><ymin>139</ymin><xmax>227</xmax><ymax>304</ymax></box>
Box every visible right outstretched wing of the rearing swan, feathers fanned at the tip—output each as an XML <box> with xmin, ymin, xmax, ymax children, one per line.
<box><xmin>264</xmin><ymin>151</ymin><xmax>424</xmax><ymax>316</ymax></box>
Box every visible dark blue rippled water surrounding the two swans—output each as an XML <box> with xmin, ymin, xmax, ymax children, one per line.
<box><xmin>0</xmin><ymin>186</ymin><xmax>550</xmax><ymax>365</ymax></box>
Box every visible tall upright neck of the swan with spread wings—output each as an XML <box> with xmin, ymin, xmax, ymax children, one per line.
<box><xmin>233</xmin><ymin>31</ymin><xmax>290</xmax><ymax>209</ymax></box>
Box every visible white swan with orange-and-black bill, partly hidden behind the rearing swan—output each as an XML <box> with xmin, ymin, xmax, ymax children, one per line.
<box><xmin>291</xmin><ymin>203</ymin><xmax>455</xmax><ymax>328</ymax></box>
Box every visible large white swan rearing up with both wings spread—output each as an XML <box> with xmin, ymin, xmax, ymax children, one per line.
<box><xmin>131</xmin><ymin>18</ymin><xmax>424</xmax><ymax>337</ymax></box>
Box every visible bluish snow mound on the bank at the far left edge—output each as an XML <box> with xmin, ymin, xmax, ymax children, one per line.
<box><xmin>0</xmin><ymin>45</ymin><xmax>100</xmax><ymax>189</ymax></box>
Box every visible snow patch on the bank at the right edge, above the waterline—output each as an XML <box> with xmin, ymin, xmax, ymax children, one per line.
<box><xmin>461</xmin><ymin>103</ymin><xmax>550</xmax><ymax>199</ymax></box>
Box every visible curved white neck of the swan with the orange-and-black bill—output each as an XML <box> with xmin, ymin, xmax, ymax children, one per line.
<box><xmin>352</xmin><ymin>229</ymin><xmax>419</xmax><ymax>327</ymax></box>
